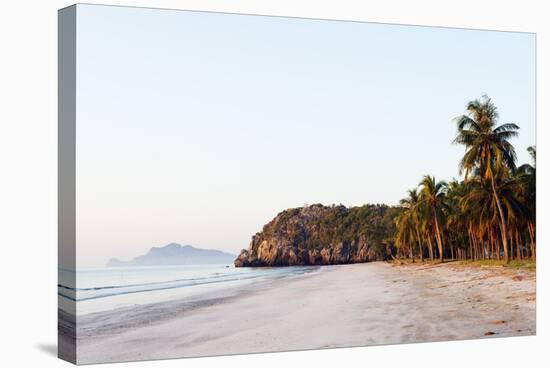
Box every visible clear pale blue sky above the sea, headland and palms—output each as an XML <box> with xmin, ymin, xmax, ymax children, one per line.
<box><xmin>72</xmin><ymin>5</ymin><xmax>535</xmax><ymax>267</ymax></box>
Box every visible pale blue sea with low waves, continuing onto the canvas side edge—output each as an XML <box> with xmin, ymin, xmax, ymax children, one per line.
<box><xmin>58</xmin><ymin>264</ymin><xmax>318</xmax><ymax>316</ymax></box>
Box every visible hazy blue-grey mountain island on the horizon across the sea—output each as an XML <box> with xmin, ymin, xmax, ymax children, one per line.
<box><xmin>107</xmin><ymin>243</ymin><xmax>235</xmax><ymax>267</ymax></box>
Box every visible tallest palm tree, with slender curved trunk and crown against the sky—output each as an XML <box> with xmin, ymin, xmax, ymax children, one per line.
<box><xmin>453</xmin><ymin>96</ymin><xmax>519</xmax><ymax>262</ymax></box>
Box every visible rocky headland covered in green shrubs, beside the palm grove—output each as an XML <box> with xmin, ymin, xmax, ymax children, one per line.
<box><xmin>234</xmin><ymin>204</ymin><xmax>398</xmax><ymax>267</ymax></box>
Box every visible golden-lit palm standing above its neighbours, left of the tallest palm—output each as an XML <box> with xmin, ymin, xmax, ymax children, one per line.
<box><xmin>419</xmin><ymin>175</ymin><xmax>447</xmax><ymax>262</ymax></box>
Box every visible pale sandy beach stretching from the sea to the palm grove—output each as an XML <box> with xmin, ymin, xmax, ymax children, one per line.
<box><xmin>72</xmin><ymin>262</ymin><xmax>536</xmax><ymax>364</ymax></box>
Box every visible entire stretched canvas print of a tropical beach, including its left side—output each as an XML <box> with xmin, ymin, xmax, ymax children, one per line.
<box><xmin>58</xmin><ymin>5</ymin><xmax>537</xmax><ymax>364</ymax></box>
